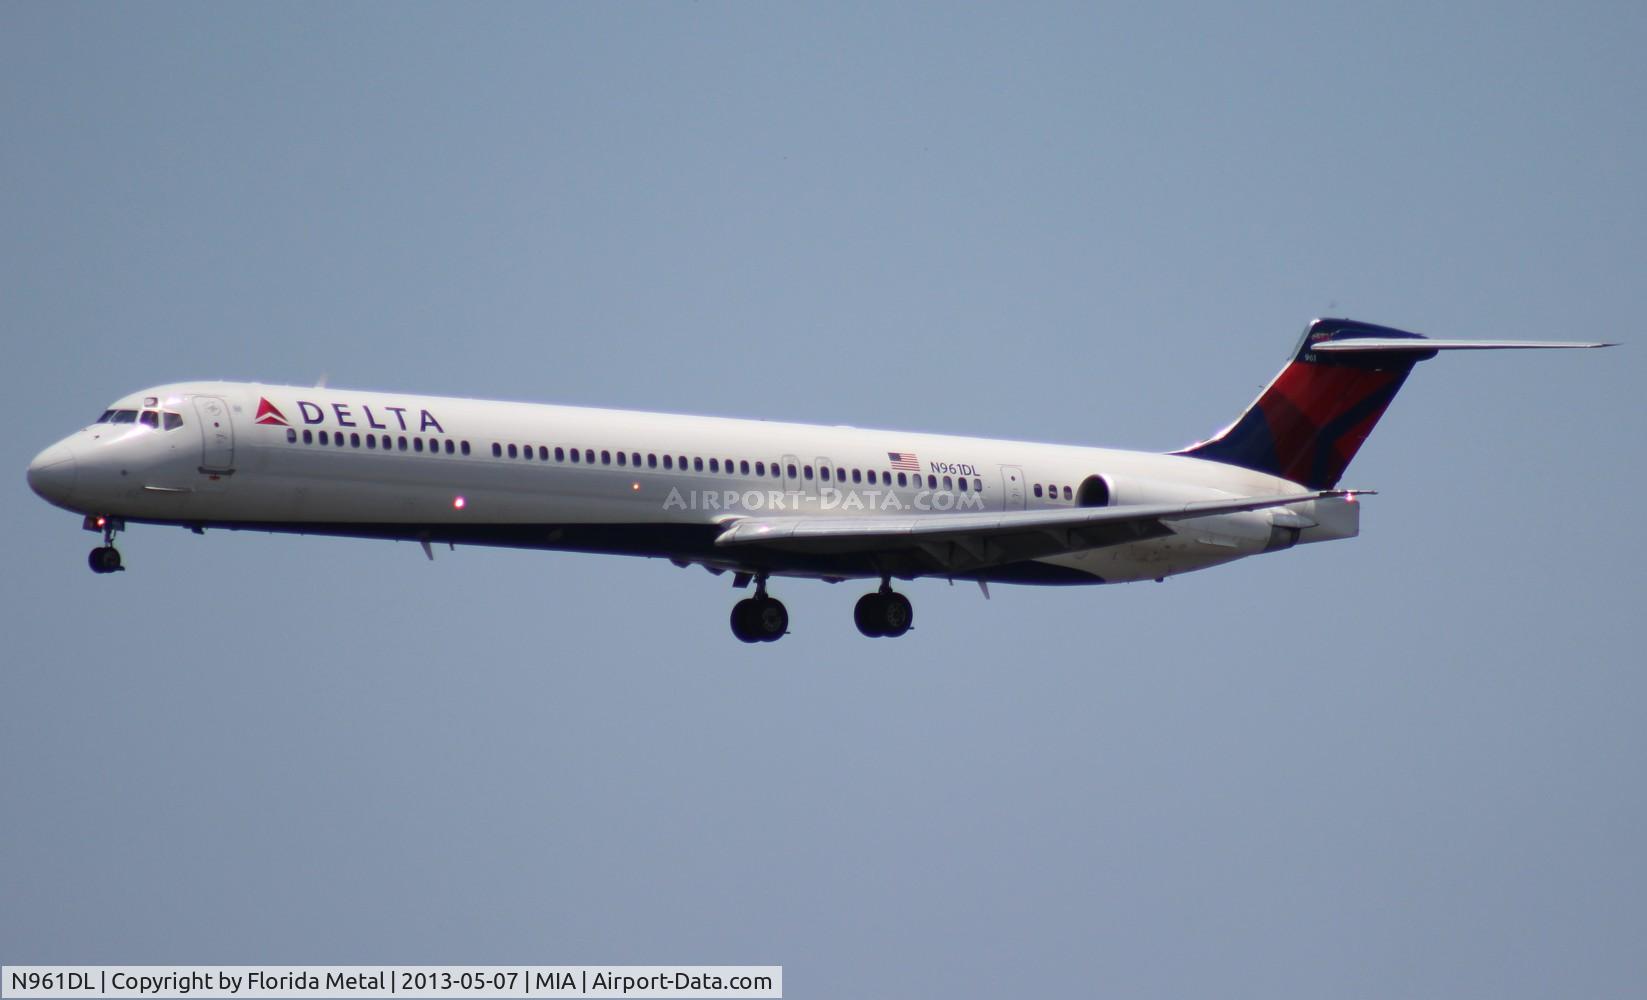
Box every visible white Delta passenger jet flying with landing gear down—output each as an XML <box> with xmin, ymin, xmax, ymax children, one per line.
<box><xmin>28</xmin><ymin>320</ymin><xmax>1614</xmax><ymax>643</ymax></box>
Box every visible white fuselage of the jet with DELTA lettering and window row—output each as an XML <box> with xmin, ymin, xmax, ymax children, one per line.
<box><xmin>31</xmin><ymin>382</ymin><xmax>1357</xmax><ymax>583</ymax></box>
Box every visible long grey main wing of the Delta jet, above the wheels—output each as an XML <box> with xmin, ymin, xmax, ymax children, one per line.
<box><xmin>715</xmin><ymin>489</ymin><xmax>1365</xmax><ymax>572</ymax></box>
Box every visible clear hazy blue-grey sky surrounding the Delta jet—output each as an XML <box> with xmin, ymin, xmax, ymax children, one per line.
<box><xmin>0</xmin><ymin>3</ymin><xmax>1647</xmax><ymax>997</ymax></box>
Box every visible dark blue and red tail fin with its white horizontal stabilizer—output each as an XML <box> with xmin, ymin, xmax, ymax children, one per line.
<box><xmin>1173</xmin><ymin>320</ymin><xmax>1611</xmax><ymax>489</ymax></box>
